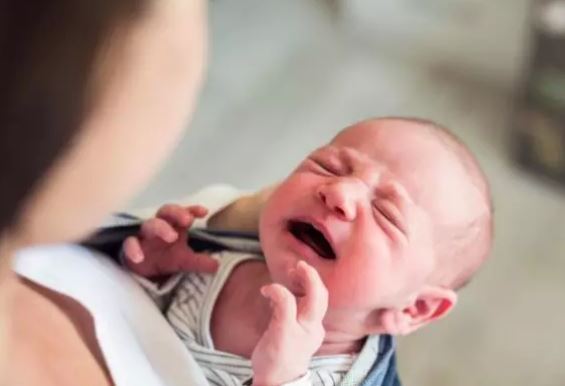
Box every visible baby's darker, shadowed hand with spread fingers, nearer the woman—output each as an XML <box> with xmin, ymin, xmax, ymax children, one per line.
<box><xmin>123</xmin><ymin>204</ymin><xmax>218</xmax><ymax>277</ymax></box>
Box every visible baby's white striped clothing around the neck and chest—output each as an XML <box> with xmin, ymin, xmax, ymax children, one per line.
<box><xmin>137</xmin><ymin>231</ymin><xmax>379</xmax><ymax>386</ymax></box>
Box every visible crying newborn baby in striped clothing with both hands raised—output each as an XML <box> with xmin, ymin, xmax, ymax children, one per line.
<box><xmin>124</xmin><ymin>118</ymin><xmax>492</xmax><ymax>386</ymax></box>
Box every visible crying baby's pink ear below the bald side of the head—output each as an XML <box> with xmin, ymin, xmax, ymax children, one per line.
<box><xmin>375</xmin><ymin>286</ymin><xmax>457</xmax><ymax>335</ymax></box>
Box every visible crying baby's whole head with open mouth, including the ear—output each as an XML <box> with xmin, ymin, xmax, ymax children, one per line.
<box><xmin>260</xmin><ymin>118</ymin><xmax>492</xmax><ymax>335</ymax></box>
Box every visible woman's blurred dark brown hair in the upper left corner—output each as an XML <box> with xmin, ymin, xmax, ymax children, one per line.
<box><xmin>0</xmin><ymin>0</ymin><xmax>146</xmax><ymax>233</ymax></box>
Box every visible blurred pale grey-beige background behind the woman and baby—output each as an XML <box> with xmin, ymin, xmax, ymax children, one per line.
<box><xmin>133</xmin><ymin>0</ymin><xmax>565</xmax><ymax>386</ymax></box>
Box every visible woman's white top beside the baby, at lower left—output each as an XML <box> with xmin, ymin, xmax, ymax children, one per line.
<box><xmin>14</xmin><ymin>245</ymin><xmax>209</xmax><ymax>386</ymax></box>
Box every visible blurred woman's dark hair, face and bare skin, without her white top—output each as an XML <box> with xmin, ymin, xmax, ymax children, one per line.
<box><xmin>0</xmin><ymin>0</ymin><xmax>206</xmax><ymax>386</ymax></box>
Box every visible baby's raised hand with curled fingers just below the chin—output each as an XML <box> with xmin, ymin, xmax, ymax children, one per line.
<box><xmin>251</xmin><ymin>261</ymin><xmax>328</xmax><ymax>386</ymax></box>
